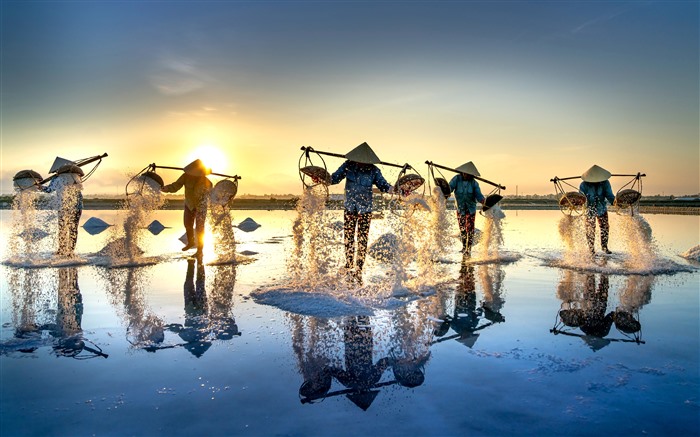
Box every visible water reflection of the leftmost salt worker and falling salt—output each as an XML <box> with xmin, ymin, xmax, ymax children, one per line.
<box><xmin>0</xmin><ymin>267</ymin><xmax>108</xmax><ymax>359</ymax></box>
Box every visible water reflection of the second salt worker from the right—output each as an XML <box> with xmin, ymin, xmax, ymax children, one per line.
<box><xmin>435</xmin><ymin>264</ymin><xmax>506</xmax><ymax>348</ymax></box>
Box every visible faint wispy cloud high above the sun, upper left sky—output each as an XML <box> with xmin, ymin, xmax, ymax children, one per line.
<box><xmin>150</xmin><ymin>55</ymin><xmax>211</xmax><ymax>96</ymax></box>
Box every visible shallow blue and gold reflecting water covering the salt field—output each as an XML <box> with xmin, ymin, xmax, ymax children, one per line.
<box><xmin>0</xmin><ymin>210</ymin><xmax>700</xmax><ymax>436</ymax></box>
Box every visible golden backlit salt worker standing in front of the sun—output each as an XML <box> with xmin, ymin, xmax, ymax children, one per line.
<box><xmin>161</xmin><ymin>159</ymin><xmax>212</xmax><ymax>256</ymax></box>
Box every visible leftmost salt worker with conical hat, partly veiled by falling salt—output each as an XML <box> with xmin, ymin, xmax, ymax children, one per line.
<box><xmin>42</xmin><ymin>164</ymin><xmax>84</xmax><ymax>256</ymax></box>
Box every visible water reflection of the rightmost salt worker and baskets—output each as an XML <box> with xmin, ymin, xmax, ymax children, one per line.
<box><xmin>550</xmin><ymin>270</ymin><xmax>654</xmax><ymax>351</ymax></box>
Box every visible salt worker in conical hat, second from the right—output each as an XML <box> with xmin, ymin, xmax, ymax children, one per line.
<box><xmin>450</xmin><ymin>161</ymin><xmax>485</xmax><ymax>257</ymax></box>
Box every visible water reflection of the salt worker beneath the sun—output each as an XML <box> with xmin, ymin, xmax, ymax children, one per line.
<box><xmin>168</xmin><ymin>259</ymin><xmax>241</xmax><ymax>358</ymax></box>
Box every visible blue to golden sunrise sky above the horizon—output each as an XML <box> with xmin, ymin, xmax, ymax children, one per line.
<box><xmin>0</xmin><ymin>0</ymin><xmax>700</xmax><ymax>195</ymax></box>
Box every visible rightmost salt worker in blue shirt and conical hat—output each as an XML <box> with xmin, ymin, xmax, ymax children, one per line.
<box><xmin>579</xmin><ymin>165</ymin><xmax>615</xmax><ymax>254</ymax></box>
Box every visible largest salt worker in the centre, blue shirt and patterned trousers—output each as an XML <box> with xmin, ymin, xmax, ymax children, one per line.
<box><xmin>331</xmin><ymin>143</ymin><xmax>393</xmax><ymax>283</ymax></box>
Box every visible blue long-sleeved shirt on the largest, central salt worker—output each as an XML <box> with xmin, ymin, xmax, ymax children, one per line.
<box><xmin>331</xmin><ymin>161</ymin><xmax>391</xmax><ymax>214</ymax></box>
